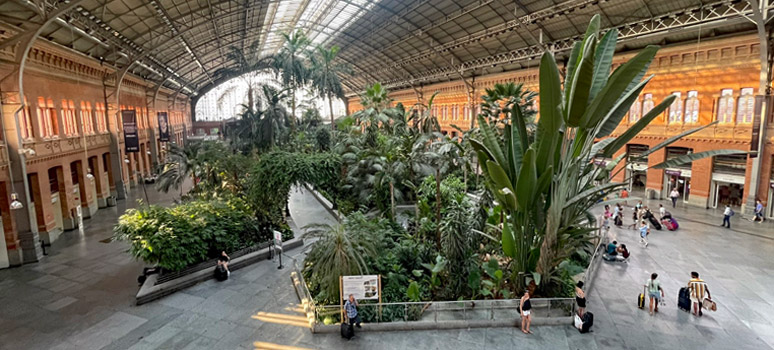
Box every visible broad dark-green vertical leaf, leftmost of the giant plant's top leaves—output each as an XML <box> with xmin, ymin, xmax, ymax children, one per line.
<box><xmin>535</xmin><ymin>51</ymin><xmax>562</xmax><ymax>173</ymax></box>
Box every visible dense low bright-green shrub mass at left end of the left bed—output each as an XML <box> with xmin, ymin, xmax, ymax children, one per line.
<box><xmin>114</xmin><ymin>198</ymin><xmax>271</xmax><ymax>271</ymax></box>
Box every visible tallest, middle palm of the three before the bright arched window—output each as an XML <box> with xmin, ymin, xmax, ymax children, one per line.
<box><xmin>275</xmin><ymin>30</ymin><xmax>310</xmax><ymax>130</ymax></box>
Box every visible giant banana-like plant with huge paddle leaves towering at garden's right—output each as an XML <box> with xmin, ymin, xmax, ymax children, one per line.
<box><xmin>471</xmin><ymin>15</ymin><xmax>739</xmax><ymax>290</ymax></box>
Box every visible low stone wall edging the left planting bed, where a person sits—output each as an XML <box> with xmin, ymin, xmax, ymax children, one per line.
<box><xmin>135</xmin><ymin>236</ymin><xmax>304</xmax><ymax>305</ymax></box>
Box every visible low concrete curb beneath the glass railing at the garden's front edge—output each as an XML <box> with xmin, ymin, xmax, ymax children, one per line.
<box><xmin>313</xmin><ymin>317</ymin><xmax>573</xmax><ymax>333</ymax></box>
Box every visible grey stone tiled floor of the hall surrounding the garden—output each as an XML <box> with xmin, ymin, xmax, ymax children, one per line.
<box><xmin>0</xmin><ymin>191</ymin><xmax>774</xmax><ymax>350</ymax></box>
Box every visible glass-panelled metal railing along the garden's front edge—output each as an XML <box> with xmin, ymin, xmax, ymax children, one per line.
<box><xmin>314</xmin><ymin>298</ymin><xmax>575</xmax><ymax>324</ymax></box>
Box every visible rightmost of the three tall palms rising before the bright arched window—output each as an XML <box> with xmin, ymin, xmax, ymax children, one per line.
<box><xmin>311</xmin><ymin>46</ymin><xmax>350</xmax><ymax>129</ymax></box>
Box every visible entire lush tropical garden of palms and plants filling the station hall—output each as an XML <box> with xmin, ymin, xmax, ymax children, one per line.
<box><xmin>115</xmin><ymin>17</ymin><xmax>738</xmax><ymax>322</ymax></box>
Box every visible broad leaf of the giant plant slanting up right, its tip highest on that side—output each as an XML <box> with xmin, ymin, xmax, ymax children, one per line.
<box><xmin>580</xmin><ymin>45</ymin><xmax>658</xmax><ymax>127</ymax></box>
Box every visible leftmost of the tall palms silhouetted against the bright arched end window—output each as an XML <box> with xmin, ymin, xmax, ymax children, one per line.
<box><xmin>214</xmin><ymin>40</ymin><xmax>276</xmax><ymax>113</ymax></box>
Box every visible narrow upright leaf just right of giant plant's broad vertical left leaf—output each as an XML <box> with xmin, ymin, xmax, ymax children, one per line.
<box><xmin>566</xmin><ymin>38</ymin><xmax>596</xmax><ymax>127</ymax></box>
